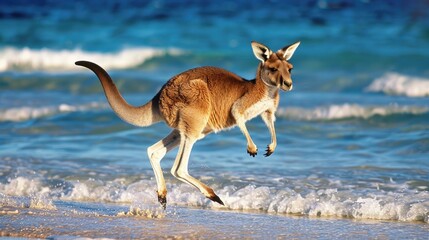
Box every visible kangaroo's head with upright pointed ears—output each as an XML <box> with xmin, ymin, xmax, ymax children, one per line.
<box><xmin>252</xmin><ymin>42</ymin><xmax>300</xmax><ymax>91</ymax></box>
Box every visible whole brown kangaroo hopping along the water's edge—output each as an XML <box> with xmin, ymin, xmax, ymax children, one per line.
<box><xmin>75</xmin><ymin>41</ymin><xmax>300</xmax><ymax>209</ymax></box>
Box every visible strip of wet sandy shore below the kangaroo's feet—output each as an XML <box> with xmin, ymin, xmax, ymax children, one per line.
<box><xmin>0</xmin><ymin>202</ymin><xmax>429</xmax><ymax>239</ymax></box>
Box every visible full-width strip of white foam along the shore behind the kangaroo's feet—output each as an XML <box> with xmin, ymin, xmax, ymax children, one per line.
<box><xmin>0</xmin><ymin>177</ymin><xmax>429</xmax><ymax>223</ymax></box>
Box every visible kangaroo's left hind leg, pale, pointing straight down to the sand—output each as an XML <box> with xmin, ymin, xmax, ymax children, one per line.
<box><xmin>147</xmin><ymin>130</ymin><xmax>180</xmax><ymax>209</ymax></box>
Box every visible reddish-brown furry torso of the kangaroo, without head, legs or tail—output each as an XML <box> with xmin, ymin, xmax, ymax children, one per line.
<box><xmin>159</xmin><ymin>67</ymin><xmax>265</xmax><ymax>134</ymax></box>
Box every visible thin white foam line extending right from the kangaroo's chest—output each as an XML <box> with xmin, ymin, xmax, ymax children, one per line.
<box><xmin>277</xmin><ymin>103</ymin><xmax>429</xmax><ymax>121</ymax></box>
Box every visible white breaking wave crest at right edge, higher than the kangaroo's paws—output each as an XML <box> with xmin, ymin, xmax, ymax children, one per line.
<box><xmin>366</xmin><ymin>73</ymin><xmax>429</xmax><ymax>97</ymax></box>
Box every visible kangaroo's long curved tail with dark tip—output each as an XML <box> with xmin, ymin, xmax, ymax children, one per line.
<box><xmin>75</xmin><ymin>61</ymin><xmax>162</xmax><ymax>127</ymax></box>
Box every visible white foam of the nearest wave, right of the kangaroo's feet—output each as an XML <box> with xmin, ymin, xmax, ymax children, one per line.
<box><xmin>217</xmin><ymin>186</ymin><xmax>429</xmax><ymax>223</ymax></box>
